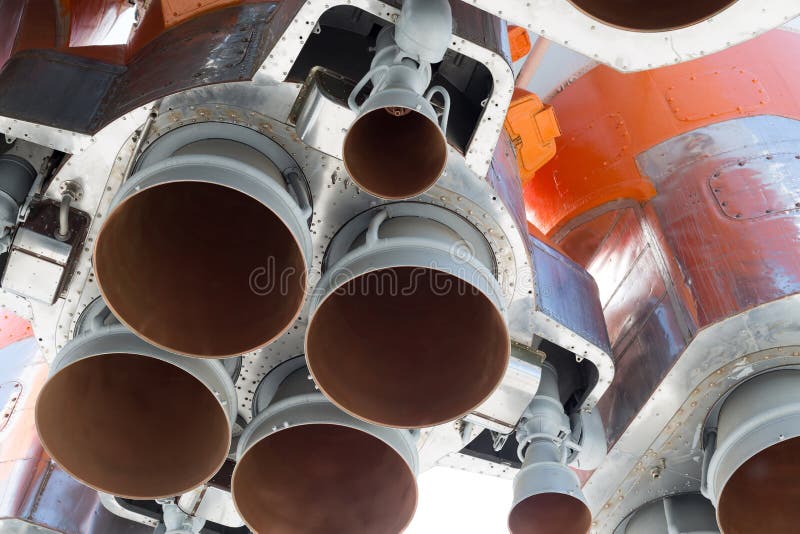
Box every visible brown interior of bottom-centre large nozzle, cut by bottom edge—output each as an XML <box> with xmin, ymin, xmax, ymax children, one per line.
<box><xmin>233</xmin><ymin>424</ymin><xmax>417</xmax><ymax>534</ymax></box>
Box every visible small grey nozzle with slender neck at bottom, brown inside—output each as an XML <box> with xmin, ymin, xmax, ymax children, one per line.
<box><xmin>508</xmin><ymin>363</ymin><xmax>592</xmax><ymax>534</ymax></box>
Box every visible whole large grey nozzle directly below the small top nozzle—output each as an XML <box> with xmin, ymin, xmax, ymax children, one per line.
<box><xmin>306</xmin><ymin>203</ymin><xmax>510</xmax><ymax>428</ymax></box>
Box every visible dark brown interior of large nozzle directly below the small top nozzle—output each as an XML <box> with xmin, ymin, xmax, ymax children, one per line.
<box><xmin>306</xmin><ymin>267</ymin><xmax>509</xmax><ymax>428</ymax></box>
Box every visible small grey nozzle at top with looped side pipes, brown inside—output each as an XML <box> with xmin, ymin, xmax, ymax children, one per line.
<box><xmin>342</xmin><ymin>20</ymin><xmax>452</xmax><ymax>199</ymax></box>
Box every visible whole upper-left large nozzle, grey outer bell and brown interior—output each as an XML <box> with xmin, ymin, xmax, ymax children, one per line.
<box><xmin>94</xmin><ymin>123</ymin><xmax>311</xmax><ymax>358</ymax></box>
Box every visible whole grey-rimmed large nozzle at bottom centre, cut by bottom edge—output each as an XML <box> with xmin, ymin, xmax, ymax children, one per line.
<box><xmin>232</xmin><ymin>357</ymin><xmax>417</xmax><ymax>534</ymax></box>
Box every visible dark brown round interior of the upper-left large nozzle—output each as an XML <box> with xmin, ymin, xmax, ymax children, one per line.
<box><xmin>94</xmin><ymin>182</ymin><xmax>306</xmax><ymax>358</ymax></box>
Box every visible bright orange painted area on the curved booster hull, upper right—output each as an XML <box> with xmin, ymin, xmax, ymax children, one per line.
<box><xmin>523</xmin><ymin>30</ymin><xmax>800</xmax><ymax>235</ymax></box>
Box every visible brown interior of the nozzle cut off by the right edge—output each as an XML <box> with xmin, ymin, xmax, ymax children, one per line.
<box><xmin>717</xmin><ymin>438</ymin><xmax>800</xmax><ymax>534</ymax></box>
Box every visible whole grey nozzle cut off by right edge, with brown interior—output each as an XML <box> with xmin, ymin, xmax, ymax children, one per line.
<box><xmin>706</xmin><ymin>369</ymin><xmax>800</xmax><ymax>534</ymax></box>
